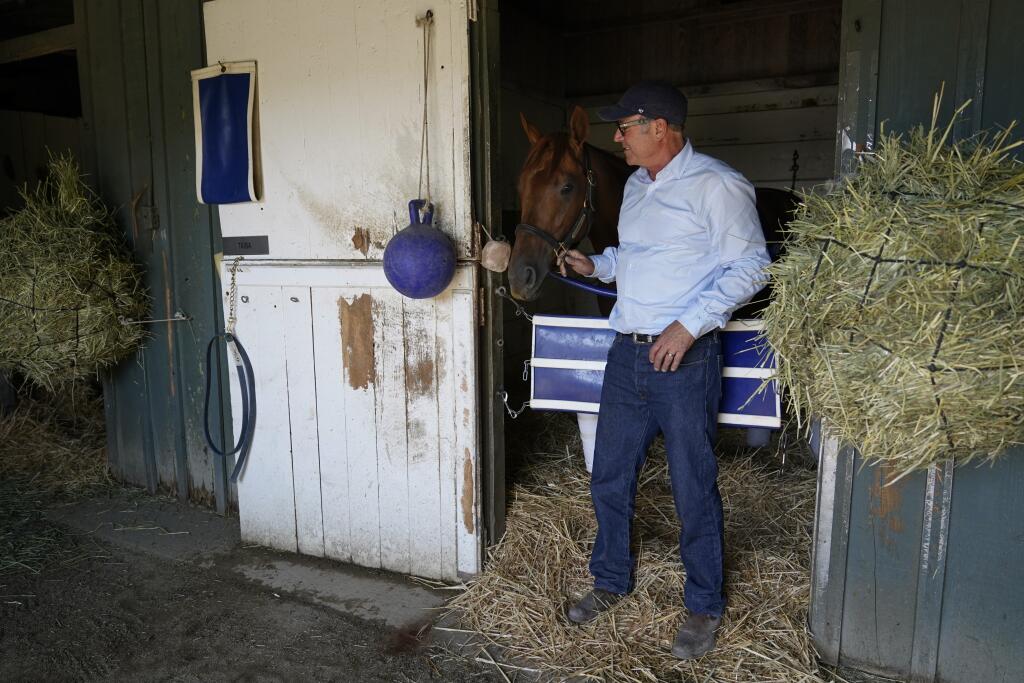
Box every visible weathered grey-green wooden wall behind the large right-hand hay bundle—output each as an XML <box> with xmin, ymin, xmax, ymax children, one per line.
<box><xmin>810</xmin><ymin>0</ymin><xmax>1024</xmax><ymax>683</ymax></box>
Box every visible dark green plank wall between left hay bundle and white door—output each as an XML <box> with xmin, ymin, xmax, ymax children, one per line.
<box><xmin>76</xmin><ymin>0</ymin><xmax>230</xmax><ymax>510</ymax></box>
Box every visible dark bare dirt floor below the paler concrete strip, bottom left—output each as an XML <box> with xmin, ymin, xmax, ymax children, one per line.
<box><xmin>0</xmin><ymin>482</ymin><xmax>502</xmax><ymax>683</ymax></box>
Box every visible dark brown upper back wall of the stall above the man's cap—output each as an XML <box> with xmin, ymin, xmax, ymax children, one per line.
<box><xmin>564</xmin><ymin>0</ymin><xmax>842</xmax><ymax>97</ymax></box>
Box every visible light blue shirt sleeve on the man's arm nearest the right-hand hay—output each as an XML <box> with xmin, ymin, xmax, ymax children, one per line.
<box><xmin>678</xmin><ymin>175</ymin><xmax>770</xmax><ymax>338</ymax></box>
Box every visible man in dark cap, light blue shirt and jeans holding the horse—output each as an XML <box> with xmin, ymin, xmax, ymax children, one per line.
<box><xmin>565</xmin><ymin>81</ymin><xmax>769</xmax><ymax>658</ymax></box>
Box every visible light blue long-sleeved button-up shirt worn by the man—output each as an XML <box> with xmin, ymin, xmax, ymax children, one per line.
<box><xmin>591</xmin><ymin>141</ymin><xmax>769</xmax><ymax>338</ymax></box>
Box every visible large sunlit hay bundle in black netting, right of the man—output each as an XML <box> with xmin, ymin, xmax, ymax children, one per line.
<box><xmin>764</xmin><ymin>97</ymin><xmax>1024</xmax><ymax>474</ymax></box>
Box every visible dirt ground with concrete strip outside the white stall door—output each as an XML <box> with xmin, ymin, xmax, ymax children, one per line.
<box><xmin>0</xmin><ymin>395</ymin><xmax>897</xmax><ymax>683</ymax></box>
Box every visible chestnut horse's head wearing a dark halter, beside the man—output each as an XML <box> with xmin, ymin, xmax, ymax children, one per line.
<box><xmin>508</xmin><ymin>106</ymin><xmax>598</xmax><ymax>301</ymax></box>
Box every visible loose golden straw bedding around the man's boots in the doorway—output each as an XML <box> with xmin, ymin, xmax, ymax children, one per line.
<box><xmin>452</xmin><ymin>415</ymin><xmax>833</xmax><ymax>683</ymax></box>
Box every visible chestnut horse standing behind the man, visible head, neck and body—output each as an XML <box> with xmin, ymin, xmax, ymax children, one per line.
<box><xmin>508</xmin><ymin>105</ymin><xmax>799</xmax><ymax>317</ymax></box>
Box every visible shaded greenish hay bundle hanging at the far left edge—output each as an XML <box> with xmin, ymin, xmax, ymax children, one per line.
<box><xmin>0</xmin><ymin>157</ymin><xmax>148</xmax><ymax>387</ymax></box>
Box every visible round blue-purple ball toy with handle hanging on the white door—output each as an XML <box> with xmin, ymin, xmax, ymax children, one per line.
<box><xmin>384</xmin><ymin>200</ymin><xmax>456</xmax><ymax>299</ymax></box>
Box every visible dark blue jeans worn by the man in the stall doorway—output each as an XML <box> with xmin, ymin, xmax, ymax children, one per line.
<box><xmin>590</xmin><ymin>332</ymin><xmax>725</xmax><ymax>615</ymax></box>
